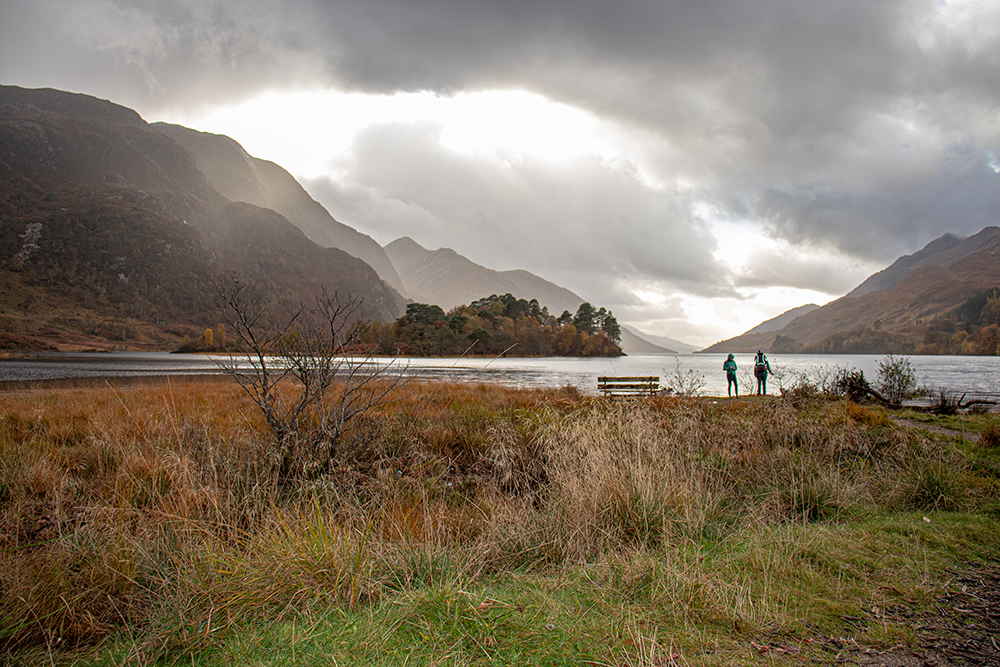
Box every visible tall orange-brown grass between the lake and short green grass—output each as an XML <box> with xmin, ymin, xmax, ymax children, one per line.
<box><xmin>0</xmin><ymin>380</ymin><xmax>990</xmax><ymax>664</ymax></box>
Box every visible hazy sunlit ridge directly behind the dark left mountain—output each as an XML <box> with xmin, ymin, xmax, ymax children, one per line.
<box><xmin>149</xmin><ymin>123</ymin><xmax>404</xmax><ymax>292</ymax></box>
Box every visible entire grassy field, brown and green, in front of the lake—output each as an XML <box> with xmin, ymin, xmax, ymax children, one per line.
<box><xmin>0</xmin><ymin>378</ymin><xmax>1000</xmax><ymax>667</ymax></box>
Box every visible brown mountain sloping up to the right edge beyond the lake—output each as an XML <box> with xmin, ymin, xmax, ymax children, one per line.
<box><xmin>704</xmin><ymin>227</ymin><xmax>1000</xmax><ymax>352</ymax></box>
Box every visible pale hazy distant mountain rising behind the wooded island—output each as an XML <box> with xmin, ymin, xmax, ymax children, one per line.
<box><xmin>385</xmin><ymin>236</ymin><xmax>584</xmax><ymax>316</ymax></box>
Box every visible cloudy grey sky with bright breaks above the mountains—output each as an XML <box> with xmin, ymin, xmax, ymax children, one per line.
<box><xmin>0</xmin><ymin>0</ymin><xmax>1000</xmax><ymax>346</ymax></box>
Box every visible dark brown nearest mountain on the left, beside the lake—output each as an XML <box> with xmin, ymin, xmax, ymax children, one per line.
<box><xmin>0</xmin><ymin>86</ymin><xmax>404</xmax><ymax>348</ymax></box>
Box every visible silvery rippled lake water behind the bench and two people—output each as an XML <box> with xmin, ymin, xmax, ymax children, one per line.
<box><xmin>0</xmin><ymin>352</ymin><xmax>1000</xmax><ymax>397</ymax></box>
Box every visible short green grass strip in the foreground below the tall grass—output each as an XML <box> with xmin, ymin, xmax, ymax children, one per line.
<box><xmin>66</xmin><ymin>513</ymin><xmax>1000</xmax><ymax>666</ymax></box>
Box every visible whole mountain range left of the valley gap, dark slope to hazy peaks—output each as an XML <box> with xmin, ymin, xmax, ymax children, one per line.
<box><xmin>0</xmin><ymin>86</ymin><xmax>693</xmax><ymax>353</ymax></box>
